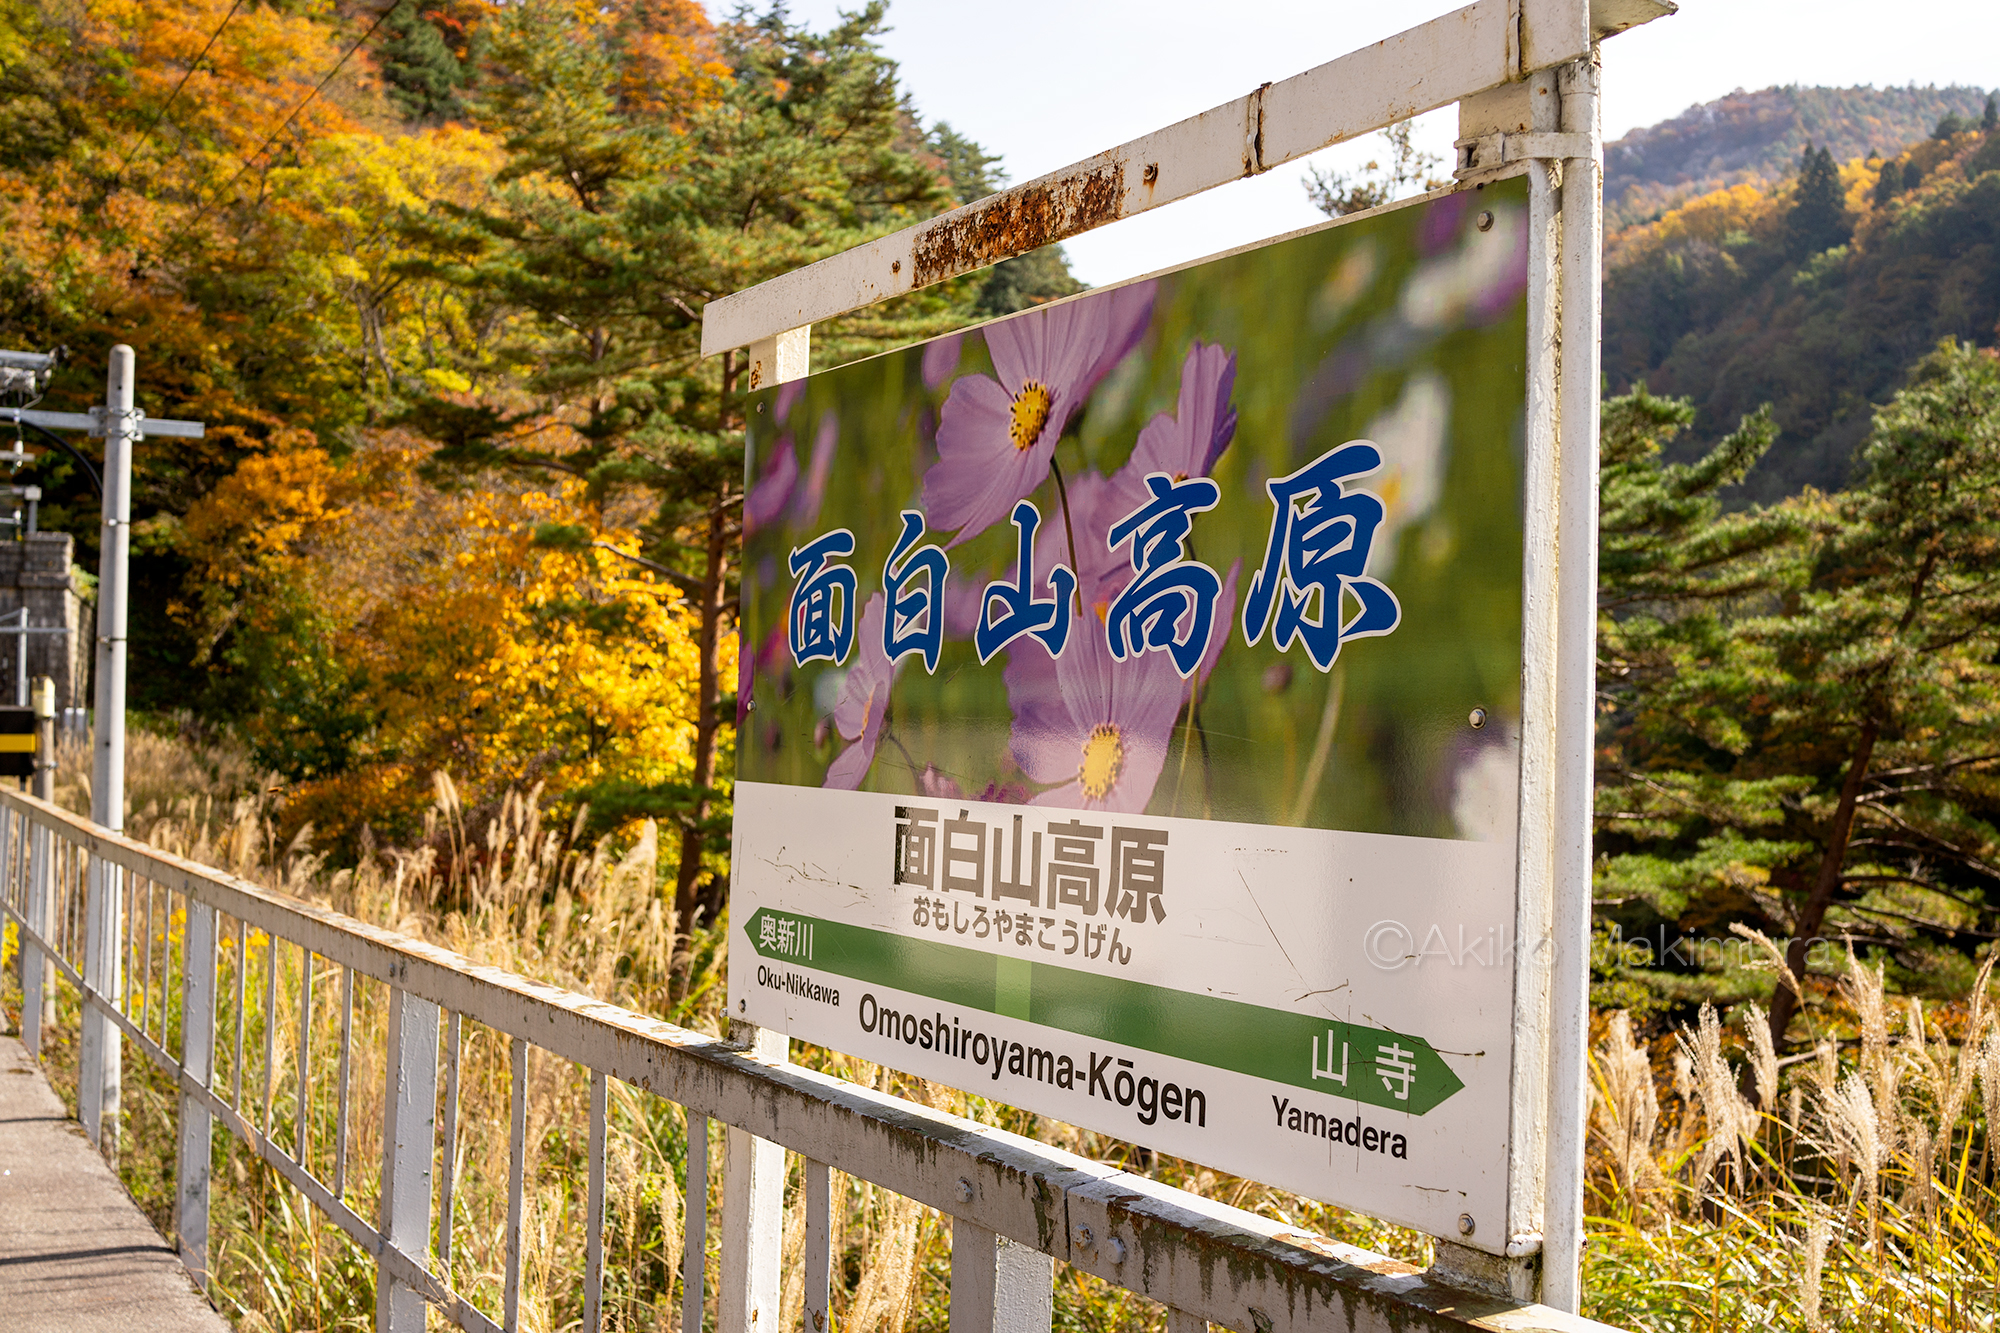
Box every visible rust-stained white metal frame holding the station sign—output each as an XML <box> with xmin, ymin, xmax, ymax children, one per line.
<box><xmin>702</xmin><ymin>0</ymin><xmax>1674</xmax><ymax>1311</ymax></box>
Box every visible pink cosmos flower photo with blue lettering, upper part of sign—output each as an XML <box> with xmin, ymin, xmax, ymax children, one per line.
<box><xmin>738</xmin><ymin>182</ymin><xmax>1526</xmax><ymax>839</ymax></box>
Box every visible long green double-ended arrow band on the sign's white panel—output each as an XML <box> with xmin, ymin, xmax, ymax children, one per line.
<box><xmin>744</xmin><ymin>907</ymin><xmax>1464</xmax><ymax>1115</ymax></box>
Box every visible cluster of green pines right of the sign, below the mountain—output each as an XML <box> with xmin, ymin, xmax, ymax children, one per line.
<box><xmin>1596</xmin><ymin>342</ymin><xmax>2000</xmax><ymax>1045</ymax></box>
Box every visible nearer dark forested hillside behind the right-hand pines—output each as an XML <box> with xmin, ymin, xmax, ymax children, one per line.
<box><xmin>1604</xmin><ymin>90</ymin><xmax>2000</xmax><ymax>502</ymax></box>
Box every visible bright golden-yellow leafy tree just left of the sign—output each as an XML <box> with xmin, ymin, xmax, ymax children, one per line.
<box><xmin>182</xmin><ymin>438</ymin><xmax>716</xmax><ymax>841</ymax></box>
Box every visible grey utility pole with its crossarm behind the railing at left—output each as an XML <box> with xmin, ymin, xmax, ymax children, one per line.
<box><xmin>0</xmin><ymin>342</ymin><xmax>204</xmax><ymax>1157</ymax></box>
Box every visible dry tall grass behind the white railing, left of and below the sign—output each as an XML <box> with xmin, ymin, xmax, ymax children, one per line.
<box><xmin>6</xmin><ymin>733</ymin><xmax>1428</xmax><ymax>1333</ymax></box>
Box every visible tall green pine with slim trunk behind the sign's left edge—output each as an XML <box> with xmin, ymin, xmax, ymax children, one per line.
<box><xmin>402</xmin><ymin>2</ymin><xmax>976</xmax><ymax>929</ymax></box>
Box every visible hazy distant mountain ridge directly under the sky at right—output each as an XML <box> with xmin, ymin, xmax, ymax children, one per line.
<box><xmin>1604</xmin><ymin>84</ymin><xmax>1986</xmax><ymax>226</ymax></box>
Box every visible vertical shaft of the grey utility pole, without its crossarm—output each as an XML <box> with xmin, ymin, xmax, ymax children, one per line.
<box><xmin>78</xmin><ymin>342</ymin><xmax>138</xmax><ymax>1155</ymax></box>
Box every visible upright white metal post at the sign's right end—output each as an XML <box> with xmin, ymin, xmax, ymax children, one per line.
<box><xmin>1542</xmin><ymin>50</ymin><xmax>1604</xmax><ymax>1313</ymax></box>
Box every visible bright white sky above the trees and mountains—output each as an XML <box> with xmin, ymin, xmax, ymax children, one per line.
<box><xmin>764</xmin><ymin>0</ymin><xmax>2000</xmax><ymax>284</ymax></box>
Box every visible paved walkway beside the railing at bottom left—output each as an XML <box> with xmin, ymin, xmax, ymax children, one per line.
<box><xmin>0</xmin><ymin>1037</ymin><xmax>228</xmax><ymax>1333</ymax></box>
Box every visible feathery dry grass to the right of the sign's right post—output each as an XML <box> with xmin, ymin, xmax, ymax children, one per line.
<box><xmin>1584</xmin><ymin>951</ymin><xmax>2000</xmax><ymax>1333</ymax></box>
